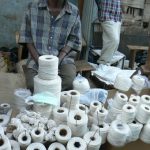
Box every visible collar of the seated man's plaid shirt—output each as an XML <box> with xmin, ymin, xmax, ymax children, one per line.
<box><xmin>38</xmin><ymin>0</ymin><xmax>72</xmax><ymax>14</ymax></box>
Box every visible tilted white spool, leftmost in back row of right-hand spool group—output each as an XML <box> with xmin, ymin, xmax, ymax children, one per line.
<box><xmin>112</xmin><ymin>92</ymin><xmax>128</xmax><ymax>109</ymax></box>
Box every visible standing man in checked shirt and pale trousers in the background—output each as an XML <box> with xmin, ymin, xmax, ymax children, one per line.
<box><xmin>95</xmin><ymin>0</ymin><xmax>126</xmax><ymax>64</ymax></box>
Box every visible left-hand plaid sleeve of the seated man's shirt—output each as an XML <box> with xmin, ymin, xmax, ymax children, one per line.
<box><xmin>19</xmin><ymin>5</ymin><xmax>33</xmax><ymax>44</ymax></box>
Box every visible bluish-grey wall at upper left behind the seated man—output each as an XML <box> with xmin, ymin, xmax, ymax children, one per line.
<box><xmin>0</xmin><ymin>0</ymin><xmax>77</xmax><ymax>48</ymax></box>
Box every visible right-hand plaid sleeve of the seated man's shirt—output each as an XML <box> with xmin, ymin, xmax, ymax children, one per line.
<box><xmin>67</xmin><ymin>13</ymin><xmax>82</xmax><ymax>51</ymax></box>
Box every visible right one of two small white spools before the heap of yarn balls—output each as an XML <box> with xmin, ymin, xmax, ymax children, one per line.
<box><xmin>31</xmin><ymin>127</ymin><xmax>45</xmax><ymax>143</ymax></box>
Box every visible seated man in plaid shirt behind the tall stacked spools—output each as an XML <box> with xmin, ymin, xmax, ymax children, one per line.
<box><xmin>19</xmin><ymin>0</ymin><xmax>81</xmax><ymax>90</ymax></box>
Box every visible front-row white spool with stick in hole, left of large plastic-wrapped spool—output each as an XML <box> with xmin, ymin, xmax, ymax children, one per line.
<box><xmin>83</xmin><ymin>130</ymin><xmax>102</xmax><ymax>150</ymax></box>
